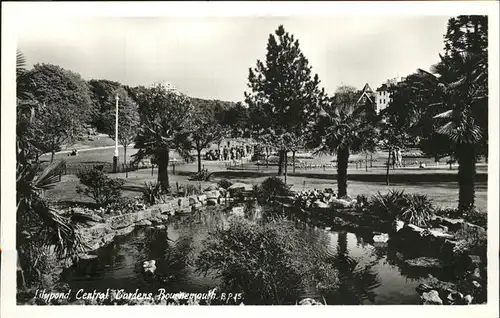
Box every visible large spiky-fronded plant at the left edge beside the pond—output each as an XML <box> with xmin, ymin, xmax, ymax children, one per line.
<box><xmin>16</xmin><ymin>161</ymin><xmax>89</xmax><ymax>285</ymax></box>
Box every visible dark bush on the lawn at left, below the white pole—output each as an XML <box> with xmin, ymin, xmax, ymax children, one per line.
<box><xmin>76</xmin><ymin>168</ymin><xmax>125</xmax><ymax>207</ymax></box>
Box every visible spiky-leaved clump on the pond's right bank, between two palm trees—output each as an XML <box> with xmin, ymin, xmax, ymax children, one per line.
<box><xmin>364</xmin><ymin>190</ymin><xmax>435</xmax><ymax>226</ymax></box>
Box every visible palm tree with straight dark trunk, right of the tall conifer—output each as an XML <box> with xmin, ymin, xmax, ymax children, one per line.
<box><xmin>310</xmin><ymin>87</ymin><xmax>378</xmax><ymax>197</ymax></box>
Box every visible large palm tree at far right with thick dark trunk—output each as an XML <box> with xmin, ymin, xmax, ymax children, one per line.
<box><xmin>419</xmin><ymin>52</ymin><xmax>488</xmax><ymax>212</ymax></box>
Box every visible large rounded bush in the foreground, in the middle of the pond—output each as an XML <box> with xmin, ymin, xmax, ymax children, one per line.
<box><xmin>196</xmin><ymin>218</ymin><xmax>338</xmax><ymax>305</ymax></box>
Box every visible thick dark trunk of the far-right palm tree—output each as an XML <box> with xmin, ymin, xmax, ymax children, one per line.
<box><xmin>457</xmin><ymin>145</ymin><xmax>476</xmax><ymax>212</ymax></box>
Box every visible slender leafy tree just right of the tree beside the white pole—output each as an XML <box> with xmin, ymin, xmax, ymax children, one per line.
<box><xmin>191</xmin><ymin>103</ymin><xmax>224</xmax><ymax>173</ymax></box>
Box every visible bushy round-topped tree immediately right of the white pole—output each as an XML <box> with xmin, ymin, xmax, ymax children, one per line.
<box><xmin>131</xmin><ymin>83</ymin><xmax>193</xmax><ymax>191</ymax></box>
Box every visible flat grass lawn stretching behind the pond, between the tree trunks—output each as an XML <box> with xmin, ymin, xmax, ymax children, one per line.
<box><xmin>47</xmin><ymin>158</ymin><xmax>487</xmax><ymax>212</ymax></box>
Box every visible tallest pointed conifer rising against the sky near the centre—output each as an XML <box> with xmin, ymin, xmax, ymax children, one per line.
<box><xmin>245</xmin><ymin>25</ymin><xmax>324</xmax><ymax>175</ymax></box>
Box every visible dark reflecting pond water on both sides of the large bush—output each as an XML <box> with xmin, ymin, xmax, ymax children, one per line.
<box><xmin>63</xmin><ymin>208</ymin><xmax>430</xmax><ymax>304</ymax></box>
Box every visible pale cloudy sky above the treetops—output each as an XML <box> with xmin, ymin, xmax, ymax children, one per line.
<box><xmin>18</xmin><ymin>16</ymin><xmax>449</xmax><ymax>101</ymax></box>
